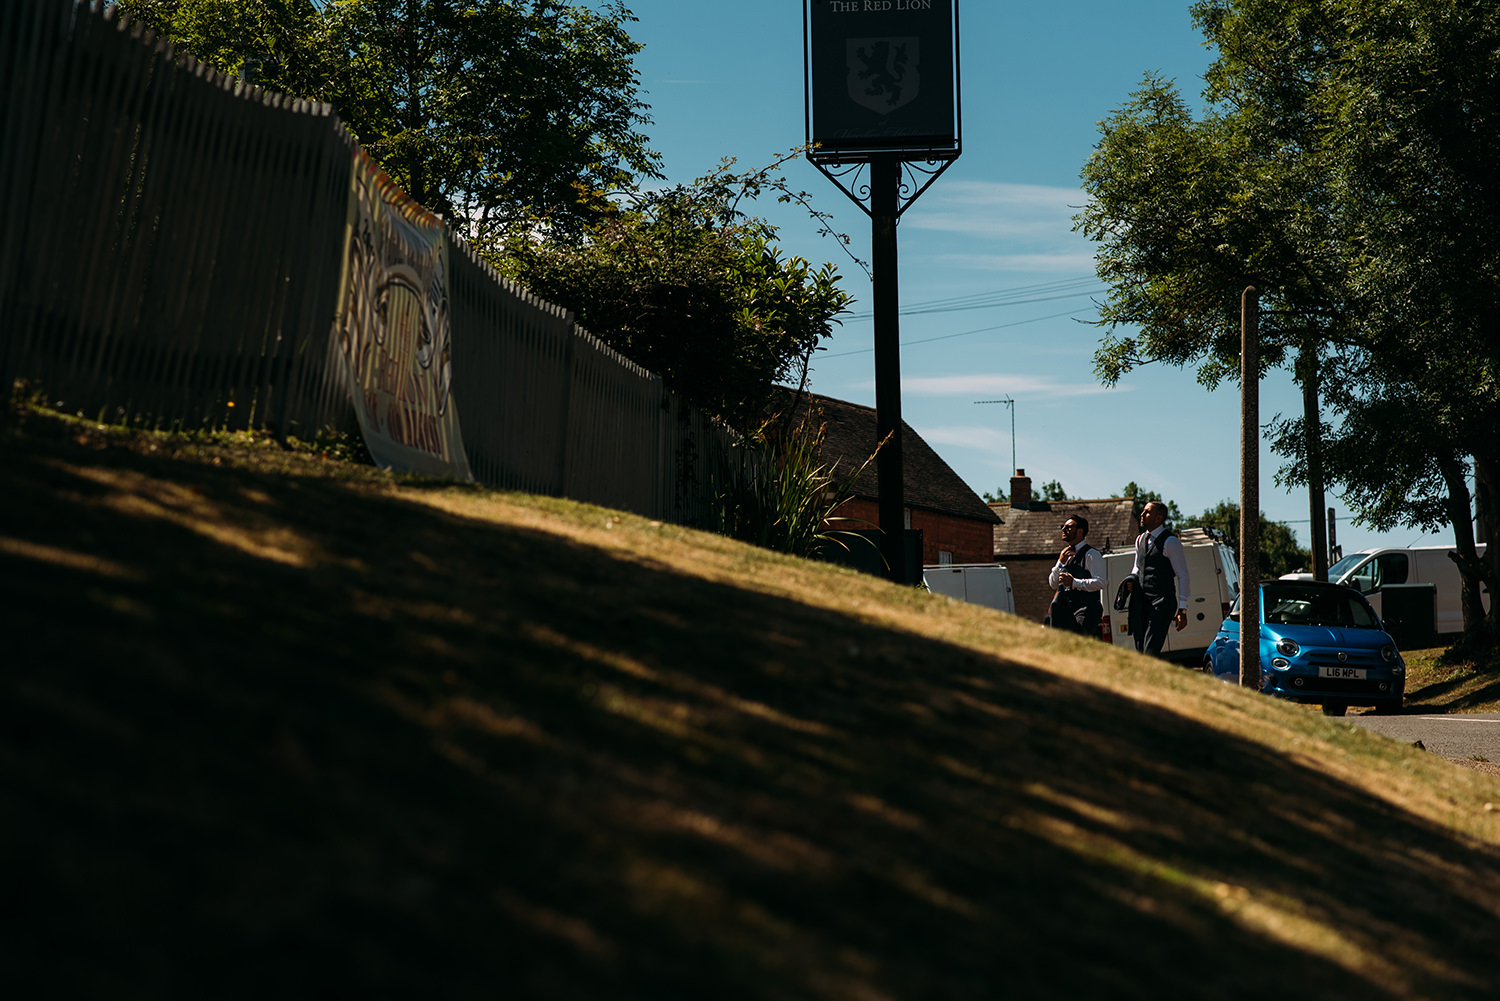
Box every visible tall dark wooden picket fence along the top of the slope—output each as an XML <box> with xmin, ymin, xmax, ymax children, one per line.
<box><xmin>0</xmin><ymin>0</ymin><xmax>728</xmax><ymax>522</ymax></box>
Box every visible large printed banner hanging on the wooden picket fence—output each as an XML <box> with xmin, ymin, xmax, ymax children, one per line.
<box><xmin>338</xmin><ymin>147</ymin><xmax>474</xmax><ymax>480</ymax></box>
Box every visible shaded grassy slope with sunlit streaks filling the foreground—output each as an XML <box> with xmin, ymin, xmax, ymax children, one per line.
<box><xmin>0</xmin><ymin>416</ymin><xmax>1500</xmax><ymax>1001</ymax></box>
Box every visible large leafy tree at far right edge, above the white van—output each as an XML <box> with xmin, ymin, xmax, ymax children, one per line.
<box><xmin>1202</xmin><ymin>0</ymin><xmax>1500</xmax><ymax>648</ymax></box>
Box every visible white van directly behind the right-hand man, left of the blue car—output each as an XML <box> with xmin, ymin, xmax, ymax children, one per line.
<box><xmin>1101</xmin><ymin>528</ymin><xmax>1239</xmax><ymax>666</ymax></box>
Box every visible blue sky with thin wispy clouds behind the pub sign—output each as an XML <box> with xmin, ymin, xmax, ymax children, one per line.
<box><xmin>627</xmin><ymin>0</ymin><xmax>1451</xmax><ymax>552</ymax></box>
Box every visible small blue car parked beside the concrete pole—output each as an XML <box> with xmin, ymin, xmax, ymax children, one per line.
<box><xmin>1203</xmin><ymin>581</ymin><xmax>1406</xmax><ymax>716</ymax></box>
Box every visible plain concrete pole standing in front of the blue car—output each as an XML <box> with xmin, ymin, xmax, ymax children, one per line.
<box><xmin>1239</xmin><ymin>287</ymin><xmax>1260</xmax><ymax>689</ymax></box>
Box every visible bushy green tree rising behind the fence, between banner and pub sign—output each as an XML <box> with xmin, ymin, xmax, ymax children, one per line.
<box><xmin>494</xmin><ymin>158</ymin><xmax>852</xmax><ymax>432</ymax></box>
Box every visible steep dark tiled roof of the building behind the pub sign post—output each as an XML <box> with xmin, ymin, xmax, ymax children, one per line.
<box><xmin>785</xmin><ymin>390</ymin><xmax>1001</xmax><ymax>524</ymax></box>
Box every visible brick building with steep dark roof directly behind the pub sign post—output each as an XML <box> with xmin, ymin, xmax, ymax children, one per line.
<box><xmin>797</xmin><ymin>393</ymin><xmax>1001</xmax><ymax>564</ymax></box>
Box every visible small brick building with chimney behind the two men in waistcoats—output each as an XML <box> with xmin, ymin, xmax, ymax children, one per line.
<box><xmin>990</xmin><ymin>470</ymin><xmax>1139</xmax><ymax>623</ymax></box>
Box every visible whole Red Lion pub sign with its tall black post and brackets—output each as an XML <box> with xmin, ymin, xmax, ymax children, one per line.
<box><xmin>803</xmin><ymin>0</ymin><xmax>963</xmax><ymax>582</ymax></box>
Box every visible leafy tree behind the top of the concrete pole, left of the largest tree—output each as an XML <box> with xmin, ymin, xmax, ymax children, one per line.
<box><xmin>1077</xmin><ymin>68</ymin><xmax>1350</xmax><ymax>579</ymax></box>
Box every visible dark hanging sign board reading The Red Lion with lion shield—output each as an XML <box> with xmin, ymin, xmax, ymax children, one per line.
<box><xmin>804</xmin><ymin>0</ymin><xmax>959</xmax><ymax>161</ymax></box>
